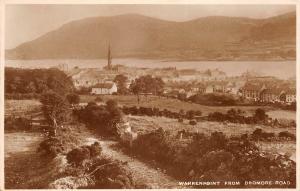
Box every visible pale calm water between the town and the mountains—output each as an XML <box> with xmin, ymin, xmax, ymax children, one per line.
<box><xmin>5</xmin><ymin>58</ymin><xmax>296</xmax><ymax>78</ymax></box>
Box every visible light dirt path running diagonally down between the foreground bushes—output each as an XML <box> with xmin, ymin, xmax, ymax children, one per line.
<box><xmin>86</xmin><ymin>138</ymin><xmax>179</xmax><ymax>189</ymax></box>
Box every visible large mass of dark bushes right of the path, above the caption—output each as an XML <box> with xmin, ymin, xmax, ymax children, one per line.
<box><xmin>122</xmin><ymin>128</ymin><xmax>296</xmax><ymax>188</ymax></box>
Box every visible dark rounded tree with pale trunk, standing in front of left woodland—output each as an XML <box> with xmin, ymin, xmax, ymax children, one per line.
<box><xmin>40</xmin><ymin>91</ymin><xmax>69</xmax><ymax>135</ymax></box>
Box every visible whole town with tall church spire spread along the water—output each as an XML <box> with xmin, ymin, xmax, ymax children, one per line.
<box><xmin>62</xmin><ymin>46</ymin><xmax>296</xmax><ymax>105</ymax></box>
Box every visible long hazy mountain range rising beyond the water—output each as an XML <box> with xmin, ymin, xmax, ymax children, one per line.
<box><xmin>6</xmin><ymin>12</ymin><xmax>296</xmax><ymax>60</ymax></box>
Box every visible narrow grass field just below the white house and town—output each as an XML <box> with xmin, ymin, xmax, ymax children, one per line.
<box><xmin>80</xmin><ymin>95</ymin><xmax>286</xmax><ymax>117</ymax></box>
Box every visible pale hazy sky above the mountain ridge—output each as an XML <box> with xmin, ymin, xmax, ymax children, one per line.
<box><xmin>5</xmin><ymin>5</ymin><xmax>296</xmax><ymax>49</ymax></box>
